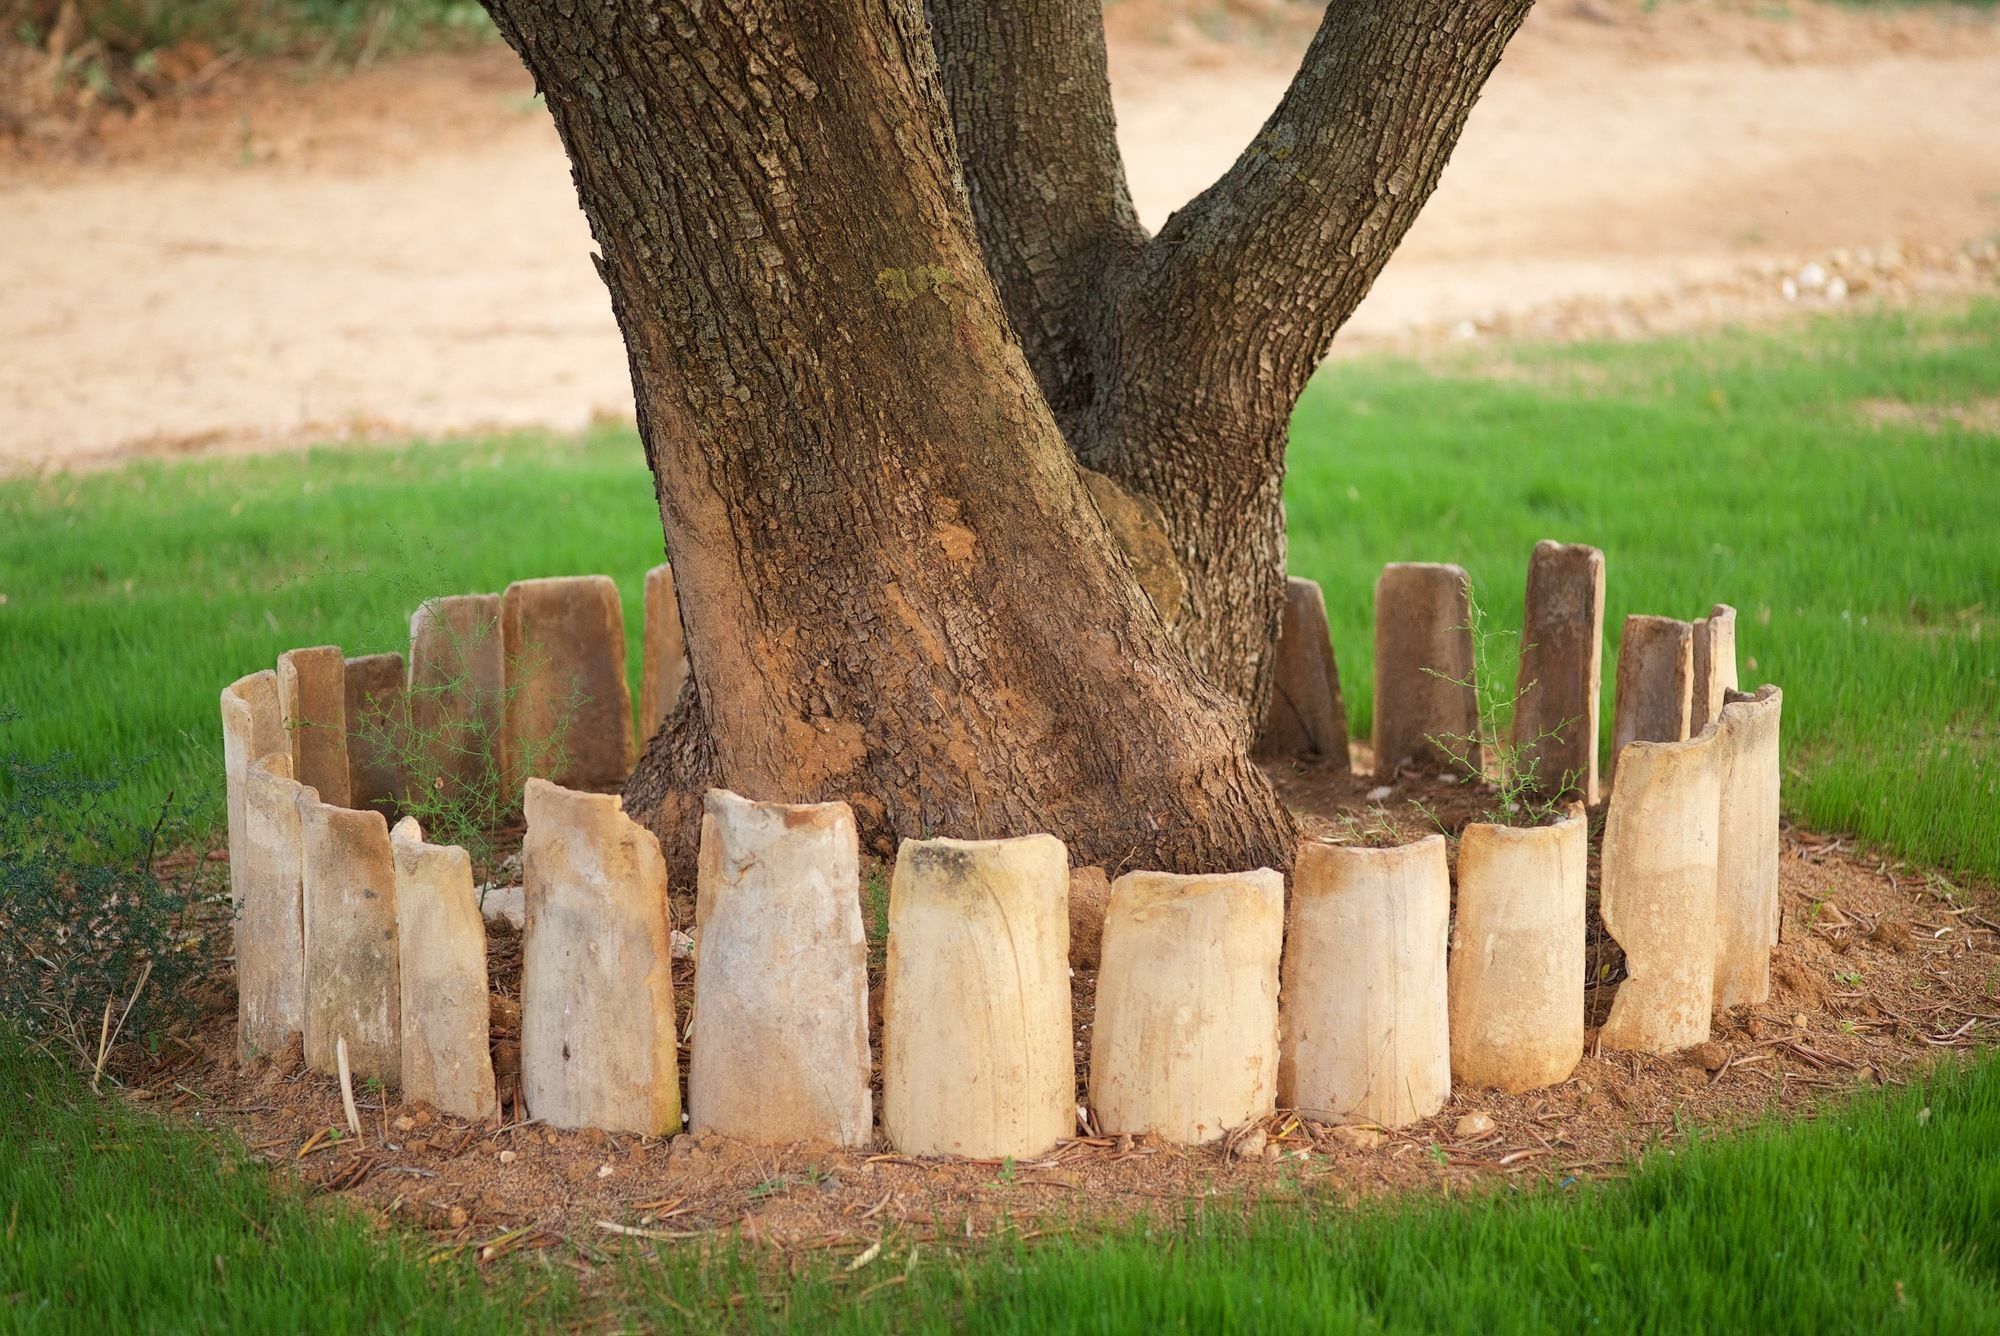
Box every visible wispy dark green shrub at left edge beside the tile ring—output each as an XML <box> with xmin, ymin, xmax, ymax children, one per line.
<box><xmin>0</xmin><ymin>712</ymin><xmax>218</xmax><ymax>1084</ymax></box>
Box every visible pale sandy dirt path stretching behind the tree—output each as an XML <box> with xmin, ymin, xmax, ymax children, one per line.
<box><xmin>0</xmin><ymin>0</ymin><xmax>2000</xmax><ymax>472</ymax></box>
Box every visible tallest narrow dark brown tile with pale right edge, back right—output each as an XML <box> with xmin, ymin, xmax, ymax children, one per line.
<box><xmin>1514</xmin><ymin>540</ymin><xmax>1604</xmax><ymax>804</ymax></box>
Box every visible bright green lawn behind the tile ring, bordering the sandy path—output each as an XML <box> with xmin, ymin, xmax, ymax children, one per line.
<box><xmin>0</xmin><ymin>302</ymin><xmax>2000</xmax><ymax>878</ymax></box>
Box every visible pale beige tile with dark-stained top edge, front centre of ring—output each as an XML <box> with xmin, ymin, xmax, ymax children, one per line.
<box><xmin>882</xmin><ymin>834</ymin><xmax>1076</xmax><ymax>1158</ymax></box>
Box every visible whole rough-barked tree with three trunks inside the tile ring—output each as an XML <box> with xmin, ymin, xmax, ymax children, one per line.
<box><xmin>486</xmin><ymin>0</ymin><xmax>1528</xmax><ymax>870</ymax></box>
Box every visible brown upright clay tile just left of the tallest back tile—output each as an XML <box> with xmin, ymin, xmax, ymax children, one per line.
<box><xmin>1374</xmin><ymin>562</ymin><xmax>1480</xmax><ymax>782</ymax></box>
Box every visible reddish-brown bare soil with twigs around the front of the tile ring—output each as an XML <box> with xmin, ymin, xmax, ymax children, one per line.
<box><xmin>128</xmin><ymin>766</ymin><xmax>2000</xmax><ymax>1270</ymax></box>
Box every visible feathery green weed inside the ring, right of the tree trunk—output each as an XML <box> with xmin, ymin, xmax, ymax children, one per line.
<box><xmin>1424</xmin><ymin>590</ymin><xmax>1580</xmax><ymax>826</ymax></box>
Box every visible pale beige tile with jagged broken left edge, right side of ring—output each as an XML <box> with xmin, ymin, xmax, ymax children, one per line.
<box><xmin>1598</xmin><ymin>728</ymin><xmax>1722</xmax><ymax>1054</ymax></box>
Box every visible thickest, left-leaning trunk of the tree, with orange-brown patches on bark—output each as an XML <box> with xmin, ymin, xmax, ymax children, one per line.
<box><xmin>488</xmin><ymin>0</ymin><xmax>1290</xmax><ymax>870</ymax></box>
